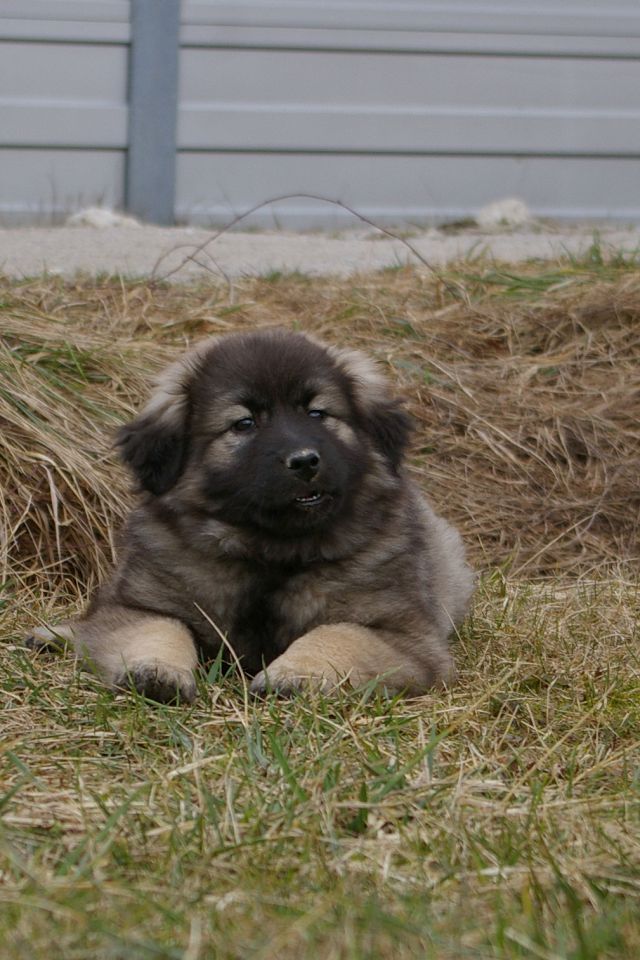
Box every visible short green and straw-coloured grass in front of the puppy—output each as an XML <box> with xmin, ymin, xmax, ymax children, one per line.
<box><xmin>0</xmin><ymin>575</ymin><xmax>640</xmax><ymax>960</ymax></box>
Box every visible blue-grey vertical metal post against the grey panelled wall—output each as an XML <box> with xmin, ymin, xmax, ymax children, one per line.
<box><xmin>125</xmin><ymin>0</ymin><xmax>180</xmax><ymax>224</ymax></box>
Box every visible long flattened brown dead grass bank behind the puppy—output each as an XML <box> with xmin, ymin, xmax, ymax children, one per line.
<box><xmin>0</xmin><ymin>264</ymin><xmax>640</xmax><ymax>593</ymax></box>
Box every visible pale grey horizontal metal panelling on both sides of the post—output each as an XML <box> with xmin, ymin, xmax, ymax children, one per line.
<box><xmin>0</xmin><ymin>0</ymin><xmax>640</xmax><ymax>227</ymax></box>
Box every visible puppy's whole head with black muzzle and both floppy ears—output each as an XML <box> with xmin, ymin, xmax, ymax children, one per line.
<box><xmin>119</xmin><ymin>330</ymin><xmax>409</xmax><ymax>538</ymax></box>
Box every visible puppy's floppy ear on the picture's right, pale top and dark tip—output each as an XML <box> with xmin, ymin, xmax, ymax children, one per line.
<box><xmin>330</xmin><ymin>347</ymin><xmax>413</xmax><ymax>471</ymax></box>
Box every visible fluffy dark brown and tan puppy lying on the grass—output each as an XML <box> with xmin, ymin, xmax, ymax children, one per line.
<box><xmin>34</xmin><ymin>330</ymin><xmax>472</xmax><ymax>701</ymax></box>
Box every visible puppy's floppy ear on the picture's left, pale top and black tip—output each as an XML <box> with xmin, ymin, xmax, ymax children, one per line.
<box><xmin>116</xmin><ymin>341</ymin><xmax>212</xmax><ymax>495</ymax></box>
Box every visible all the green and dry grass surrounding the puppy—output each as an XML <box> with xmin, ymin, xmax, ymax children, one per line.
<box><xmin>0</xmin><ymin>256</ymin><xmax>640</xmax><ymax>960</ymax></box>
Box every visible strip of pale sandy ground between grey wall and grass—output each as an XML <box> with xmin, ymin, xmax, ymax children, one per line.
<box><xmin>0</xmin><ymin>225</ymin><xmax>640</xmax><ymax>280</ymax></box>
